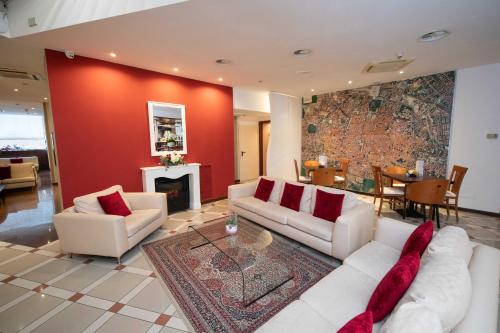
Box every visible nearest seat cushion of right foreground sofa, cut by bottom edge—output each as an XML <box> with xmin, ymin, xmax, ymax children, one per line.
<box><xmin>256</xmin><ymin>300</ymin><xmax>339</xmax><ymax>333</ymax></box>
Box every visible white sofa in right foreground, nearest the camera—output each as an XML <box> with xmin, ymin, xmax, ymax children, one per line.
<box><xmin>257</xmin><ymin>218</ymin><xmax>500</xmax><ymax>333</ymax></box>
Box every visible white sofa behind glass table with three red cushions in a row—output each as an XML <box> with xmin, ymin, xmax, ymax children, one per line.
<box><xmin>228</xmin><ymin>177</ymin><xmax>375</xmax><ymax>260</ymax></box>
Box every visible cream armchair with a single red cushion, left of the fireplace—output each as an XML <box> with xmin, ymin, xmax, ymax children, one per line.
<box><xmin>54</xmin><ymin>185</ymin><xmax>168</xmax><ymax>263</ymax></box>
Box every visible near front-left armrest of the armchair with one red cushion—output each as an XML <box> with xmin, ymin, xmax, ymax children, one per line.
<box><xmin>54</xmin><ymin>212</ymin><xmax>128</xmax><ymax>257</ymax></box>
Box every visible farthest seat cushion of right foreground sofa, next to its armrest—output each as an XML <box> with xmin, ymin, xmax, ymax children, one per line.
<box><xmin>344</xmin><ymin>241</ymin><xmax>401</xmax><ymax>281</ymax></box>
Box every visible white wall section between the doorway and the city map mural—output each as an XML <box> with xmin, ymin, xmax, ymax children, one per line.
<box><xmin>267</xmin><ymin>93</ymin><xmax>302</xmax><ymax>180</ymax></box>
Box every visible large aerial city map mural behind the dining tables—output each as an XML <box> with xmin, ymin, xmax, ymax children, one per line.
<box><xmin>302</xmin><ymin>72</ymin><xmax>455</xmax><ymax>192</ymax></box>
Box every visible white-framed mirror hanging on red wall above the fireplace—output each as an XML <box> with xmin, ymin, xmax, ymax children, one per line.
<box><xmin>148</xmin><ymin>101</ymin><xmax>187</xmax><ymax>156</ymax></box>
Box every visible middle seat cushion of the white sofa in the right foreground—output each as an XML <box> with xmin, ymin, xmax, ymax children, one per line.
<box><xmin>300</xmin><ymin>265</ymin><xmax>379</xmax><ymax>331</ymax></box>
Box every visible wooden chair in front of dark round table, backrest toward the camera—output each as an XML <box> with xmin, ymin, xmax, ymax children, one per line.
<box><xmin>405</xmin><ymin>179</ymin><xmax>450</xmax><ymax>228</ymax></box>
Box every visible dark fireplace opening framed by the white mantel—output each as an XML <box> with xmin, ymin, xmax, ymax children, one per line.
<box><xmin>155</xmin><ymin>175</ymin><xmax>189</xmax><ymax>214</ymax></box>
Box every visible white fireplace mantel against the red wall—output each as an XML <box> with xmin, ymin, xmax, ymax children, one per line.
<box><xmin>141</xmin><ymin>163</ymin><xmax>201</xmax><ymax>209</ymax></box>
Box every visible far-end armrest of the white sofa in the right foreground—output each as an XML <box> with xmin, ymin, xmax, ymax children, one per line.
<box><xmin>374</xmin><ymin>217</ymin><xmax>416</xmax><ymax>251</ymax></box>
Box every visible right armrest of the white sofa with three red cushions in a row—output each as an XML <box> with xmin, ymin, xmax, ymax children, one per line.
<box><xmin>332</xmin><ymin>202</ymin><xmax>375</xmax><ymax>260</ymax></box>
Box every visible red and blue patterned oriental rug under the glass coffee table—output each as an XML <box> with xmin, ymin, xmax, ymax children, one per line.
<box><xmin>143</xmin><ymin>219</ymin><xmax>338</xmax><ymax>332</ymax></box>
